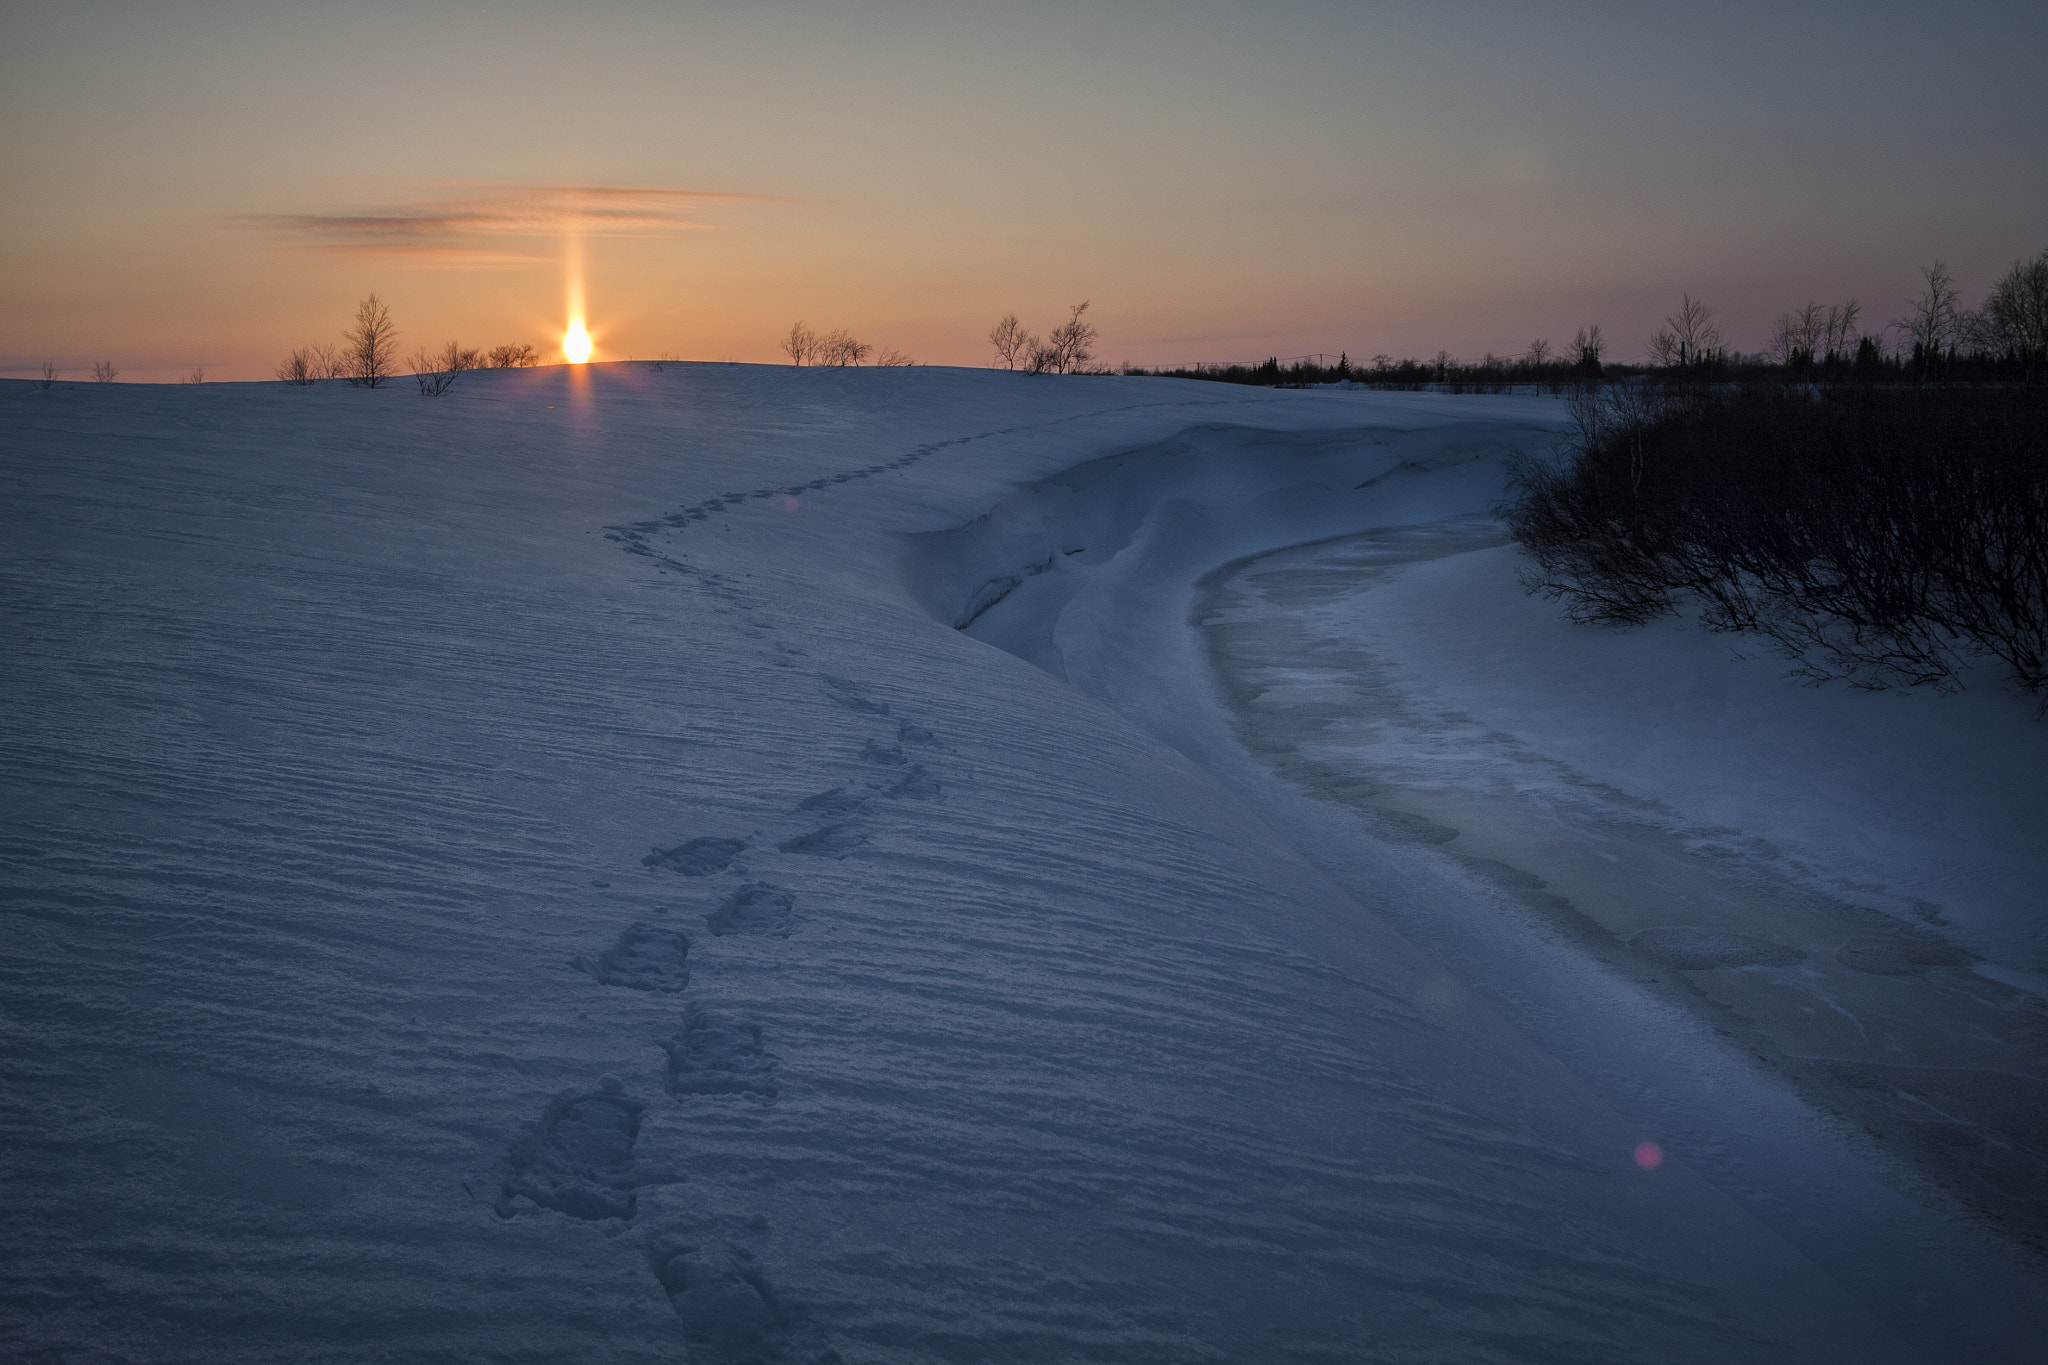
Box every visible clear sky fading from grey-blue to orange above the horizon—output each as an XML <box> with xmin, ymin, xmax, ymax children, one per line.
<box><xmin>0</xmin><ymin>0</ymin><xmax>2048</xmax><ymax>379</ymax></box>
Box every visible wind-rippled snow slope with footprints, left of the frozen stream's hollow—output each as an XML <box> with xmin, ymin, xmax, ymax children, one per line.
<box><xmin>0</xmin><ymin>366</ymin><xmax>2039</xmax><ymax>1363</ymax></box>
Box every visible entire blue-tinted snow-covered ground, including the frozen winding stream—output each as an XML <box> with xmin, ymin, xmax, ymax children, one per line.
<box><xmin>0</xmin><ymin>364</ymin><xmax>2048</xmax><ymax>1365</ymax></box>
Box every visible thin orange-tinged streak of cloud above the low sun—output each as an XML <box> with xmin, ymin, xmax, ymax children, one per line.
<box><xmin>258</xmin><ymin>184</ymin><xmax>788</xmax><ymax>266</ymax></box>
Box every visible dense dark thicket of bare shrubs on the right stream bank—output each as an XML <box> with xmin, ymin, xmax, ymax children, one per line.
<box><xmin>1501</xmin><ymin>385</ymin><xmax>2048</xmax><ymax>710</ymax></box>
